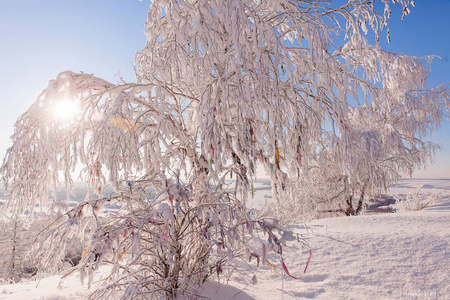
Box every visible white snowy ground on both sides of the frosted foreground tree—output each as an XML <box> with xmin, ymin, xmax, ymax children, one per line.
<box><xmin>0</xmin><ymin>179</ymin><xmax>450</xmax><ymax>300</ymax></box>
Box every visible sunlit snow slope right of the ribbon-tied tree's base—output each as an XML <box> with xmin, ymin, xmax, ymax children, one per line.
<box><xmin>205</xmin><ymin>207</ymin><xmax>450</xmax><ymax>299</ymax></box>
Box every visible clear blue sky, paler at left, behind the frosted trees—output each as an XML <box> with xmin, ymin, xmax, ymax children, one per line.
<box><xmin>0</xmin><ymin>0</ymin><xmax>450</xmax><ymax>178</ymax></box>
